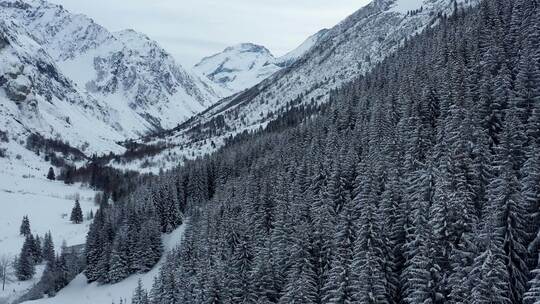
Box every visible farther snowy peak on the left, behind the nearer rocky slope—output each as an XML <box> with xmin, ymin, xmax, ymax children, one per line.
<box><xmin>0</xmin><ymin>0</ymin><xmax>223</xmax><ymax>151</ymax></box>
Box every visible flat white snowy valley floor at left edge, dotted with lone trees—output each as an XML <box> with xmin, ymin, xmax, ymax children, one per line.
<box><xmin>0</xmin><ymin>145</ymin><xmax>97</xmax><ymax>303</ymax></box>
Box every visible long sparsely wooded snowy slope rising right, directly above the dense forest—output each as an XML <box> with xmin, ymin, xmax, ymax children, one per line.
<box><xmin>118</xmin><ymin>0</ymin><xmax>478</xmax><ymax>172</ymax></box>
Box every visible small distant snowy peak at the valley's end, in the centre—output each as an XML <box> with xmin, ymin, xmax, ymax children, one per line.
<box><xmin>194</xmin><ymin>30</ymin><xmax>326</xmax><ymax>95</ymax></box>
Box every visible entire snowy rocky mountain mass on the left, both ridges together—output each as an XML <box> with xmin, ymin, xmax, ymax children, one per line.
<box><xmin>0</xmin><ymin>0</ymin><xmax>220</xmax><ymax>157</ymax></box>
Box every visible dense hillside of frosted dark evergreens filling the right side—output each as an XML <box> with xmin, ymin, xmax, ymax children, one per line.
<box><xmin>87</xmin><ymin>0</ymin><xmax>540</xmax><ymax>304</ymax></box>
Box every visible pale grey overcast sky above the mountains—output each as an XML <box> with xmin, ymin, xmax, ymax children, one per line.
<box><xmin>52</xmin><ymin>0</ymin><xmax>370</xmax><ymax>67</ymax></box>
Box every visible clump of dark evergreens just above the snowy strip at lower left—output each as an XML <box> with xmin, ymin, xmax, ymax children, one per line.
<box><xmin>85</xmin><ymin>179</ymin><xmax>192</xmax><ymax>283</ymax></box>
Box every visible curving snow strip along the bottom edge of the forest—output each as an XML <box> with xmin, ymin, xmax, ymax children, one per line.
<box><xmin>25</xmin><ymin>224</ymin><xmax>186</xmax><ymax>304</ymax></box>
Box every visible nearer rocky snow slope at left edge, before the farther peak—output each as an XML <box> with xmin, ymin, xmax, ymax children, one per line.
<box><xmin>0</xmin><ymin>17</ymin><xmax>122</xmax><ymax>152</ymax></box>
